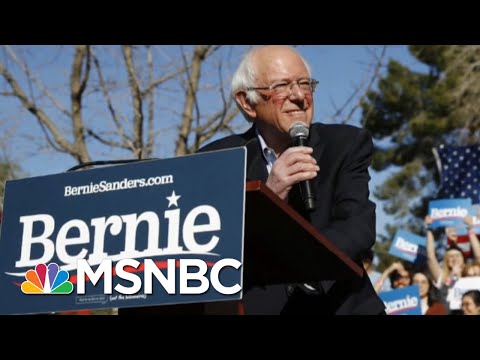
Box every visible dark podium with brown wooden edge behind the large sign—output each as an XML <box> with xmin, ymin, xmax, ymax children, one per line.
<box><xmin>119</xmin><ymin>181</ymin><xmax>363</xmax><ymax>315</ymax></box>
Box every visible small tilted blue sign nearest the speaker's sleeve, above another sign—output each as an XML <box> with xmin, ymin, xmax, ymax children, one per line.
<box><xmin>389</xmin><ymin>230</ymin><xmax>426</xmax><ymax>264</ymax></box>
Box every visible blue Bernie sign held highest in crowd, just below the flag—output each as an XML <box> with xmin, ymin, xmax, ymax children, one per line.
<box><xmin>428</xmin><ymin>199</ymin><xmax>472</xmax><ymax>229</ymax></box>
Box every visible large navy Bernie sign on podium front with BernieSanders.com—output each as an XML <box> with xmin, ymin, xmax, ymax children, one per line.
<box><xmin>0</xmin><ymin>148</ymin><xmax>246</xmax><ymax>314</ymax></box>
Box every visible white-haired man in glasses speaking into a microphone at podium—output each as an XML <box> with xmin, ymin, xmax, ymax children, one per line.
<box><xmin>199</xmin><ymin>45</ymin><xmax>385</xmax><ymax>315</ymax></box>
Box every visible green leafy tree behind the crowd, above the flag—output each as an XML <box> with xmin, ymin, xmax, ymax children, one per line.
<box><xmin>362</xmin><ymin>45</ymin><xmax>480</xmax><ymax>235</ymax></box>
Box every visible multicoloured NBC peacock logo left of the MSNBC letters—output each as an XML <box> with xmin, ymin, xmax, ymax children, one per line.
<box><xmin>22</xmin><ymin>263</ymin><xmax>73</xmax><ymax>295</ymax></box>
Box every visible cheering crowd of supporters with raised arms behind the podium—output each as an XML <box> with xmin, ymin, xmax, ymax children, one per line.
<box><xmin>363</xmin><ymin>216</ymin><xmax>480</xmax><ymax>315</ymax></box>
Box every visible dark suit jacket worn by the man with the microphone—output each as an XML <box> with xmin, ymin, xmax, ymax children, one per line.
<box><xmin>199</xmin><ymin>123</ymin><xmax>384</xmax><ymax>315</ymax></box>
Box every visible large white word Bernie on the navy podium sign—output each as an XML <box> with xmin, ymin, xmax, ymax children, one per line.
<box><xmin>13</xmin><ymin>205</ymin><xmax>221</xmax><ymax>275</ymax></box>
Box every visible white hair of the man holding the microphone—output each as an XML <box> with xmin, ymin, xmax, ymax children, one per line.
<box><xmin>232</xmin><ymin>45</ymin><xmax>311</xmax><ymax>120</ymax></box>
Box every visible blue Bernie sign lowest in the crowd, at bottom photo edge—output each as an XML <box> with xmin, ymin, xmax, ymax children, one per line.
<box><xmin>378</xmin><ymin>285</ymin><xmax>422</xmax><ymax>315</ymax></box>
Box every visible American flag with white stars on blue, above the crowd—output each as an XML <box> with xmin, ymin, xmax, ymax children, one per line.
<box><xmin>433</xmin><ymin>145</ymin><xmax>480</xmax><ymax>204</ymax></box>
